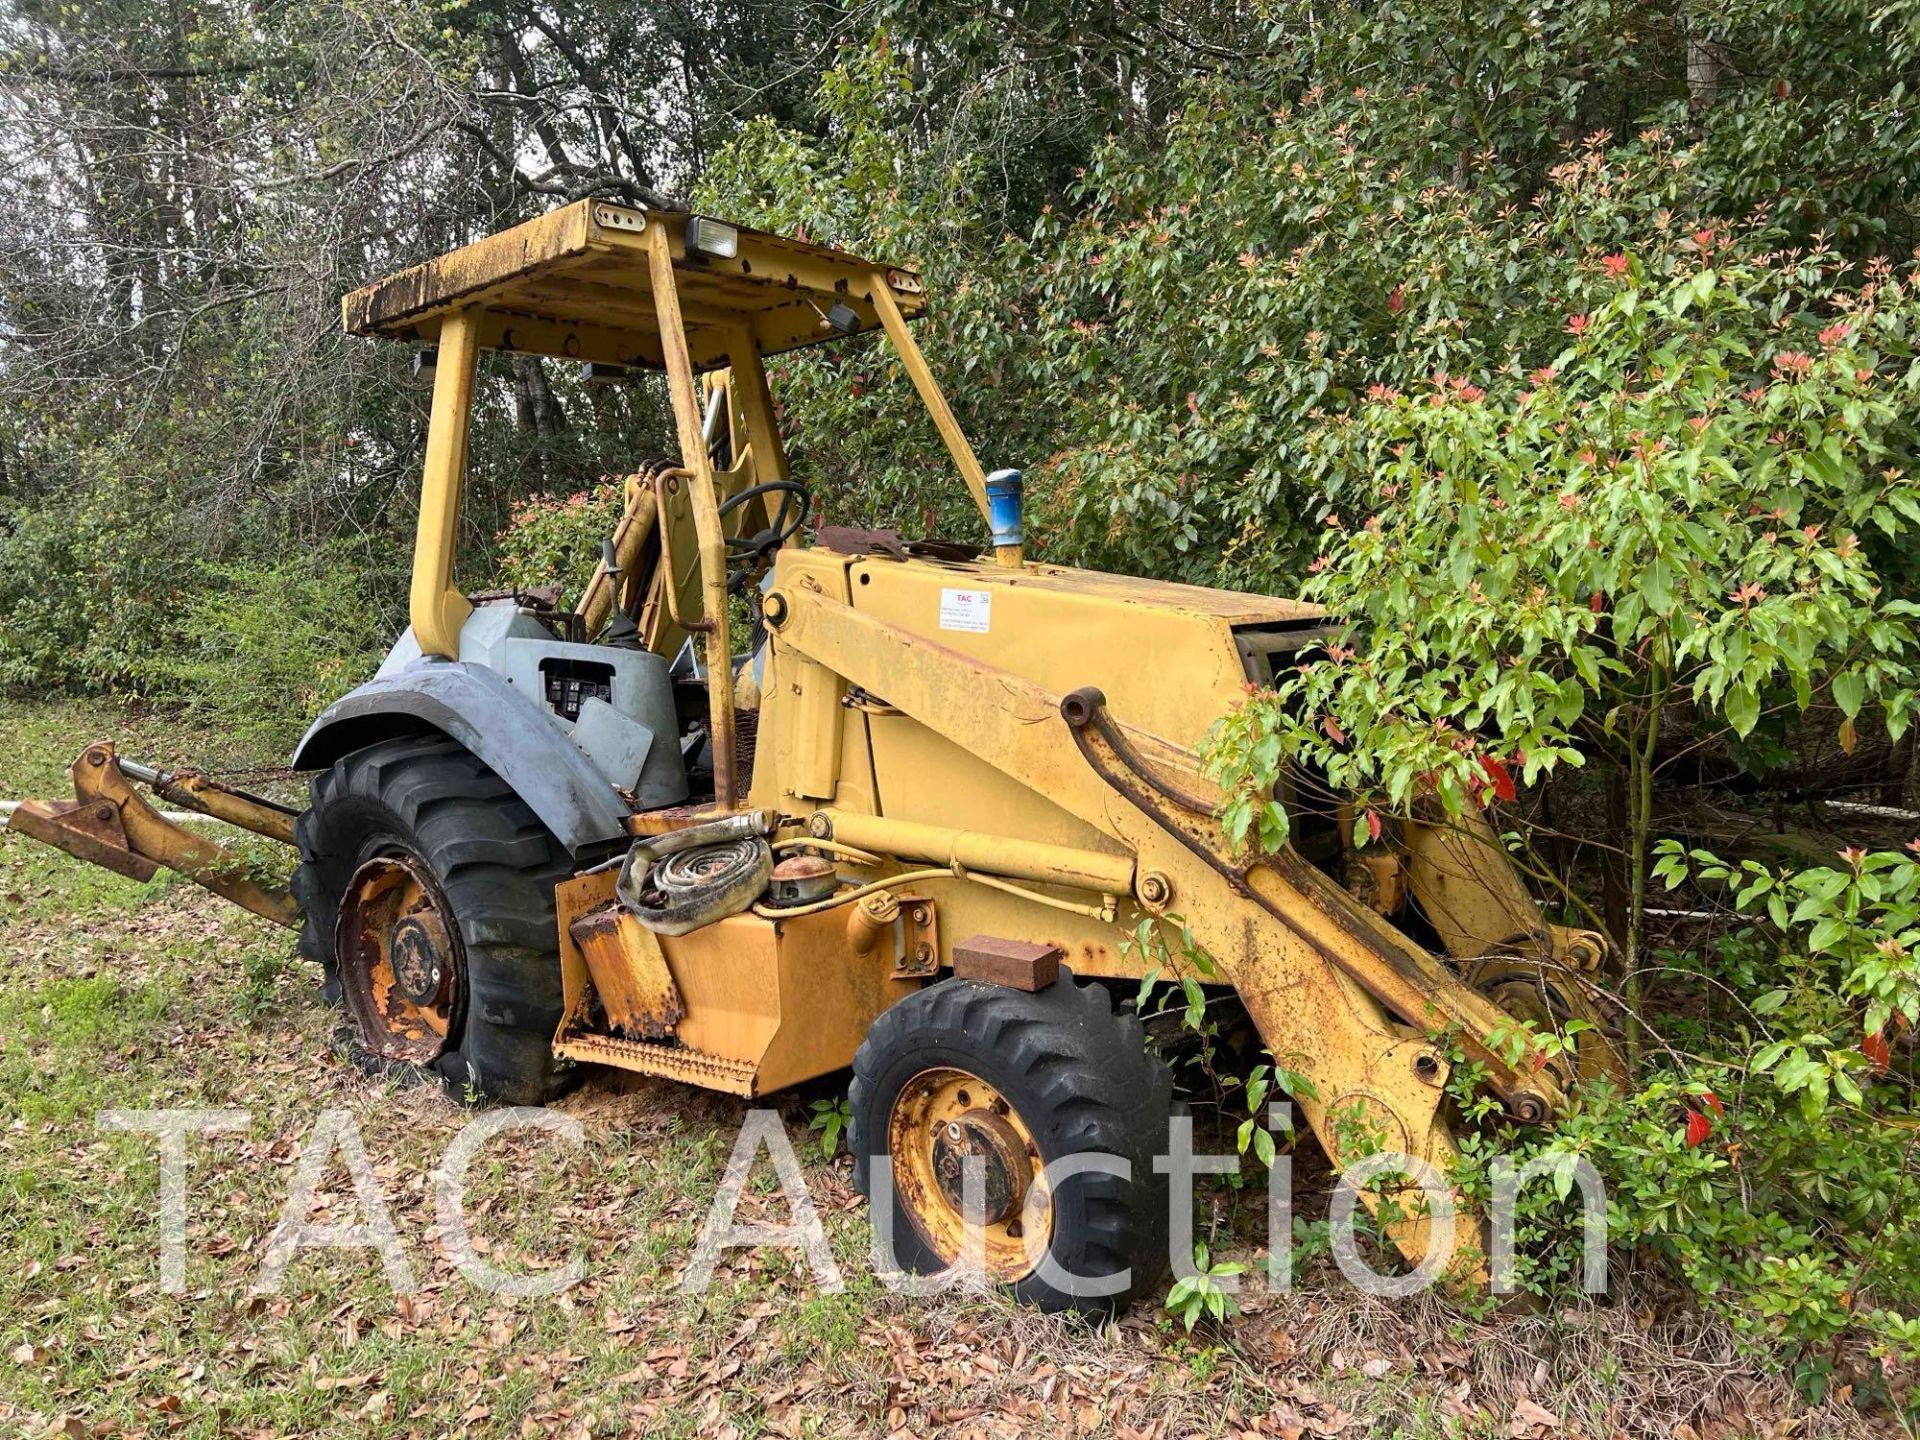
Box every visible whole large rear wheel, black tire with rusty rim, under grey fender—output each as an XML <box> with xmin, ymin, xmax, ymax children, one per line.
<box><xmin>292</xmin><ymin>735</ymin><xmax>572</xmax><ymax>1104</ymax></box>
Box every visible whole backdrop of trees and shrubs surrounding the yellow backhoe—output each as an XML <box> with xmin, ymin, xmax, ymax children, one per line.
<box><xmin>0</xmin><ymin>0</ymin><xmax>1920</xmax><ymax>1386</ymax></box>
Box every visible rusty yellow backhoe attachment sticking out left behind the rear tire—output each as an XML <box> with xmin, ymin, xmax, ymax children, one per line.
<box><xmin>8</xmin><ymin>741</ymin><xmax>300</xmax><ymax>929</ymax></box>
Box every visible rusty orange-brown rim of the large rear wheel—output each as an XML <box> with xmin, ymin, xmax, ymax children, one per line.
<box><xmin>334</xmin><ymin>854</ymin><xmax>465</xmax><ymax>1064</ymax></box>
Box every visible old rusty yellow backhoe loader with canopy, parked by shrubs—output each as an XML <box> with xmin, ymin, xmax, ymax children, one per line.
<box><xmin>12</xmin><ymin>200</ymin><xmax>1617</xmax><ymax>1308</ymax></box>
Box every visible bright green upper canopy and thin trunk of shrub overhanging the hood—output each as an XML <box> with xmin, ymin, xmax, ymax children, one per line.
<box><xmin>1213</xmin><ymin>240</ymin><xmax>1920</xmax><ymax>987</ymax></box>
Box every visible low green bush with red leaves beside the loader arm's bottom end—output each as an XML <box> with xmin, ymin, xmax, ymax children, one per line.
<box><xmin>1452</xmin><ymin>845</ymin><xmax>1920</xmax><ymax>1388</ymax></box>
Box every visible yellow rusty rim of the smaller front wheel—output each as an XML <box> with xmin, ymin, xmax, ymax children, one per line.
<box><xmin>887</xmin><ymin>1066</ymin><xmax>1054</xmax><ymax>1281</ymax></box>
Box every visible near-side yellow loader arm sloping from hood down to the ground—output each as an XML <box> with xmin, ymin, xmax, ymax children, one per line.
<box><xmin>774</xmin><ymin>586</ymin><xmax>1563</xmax><ymax>1261</ymax></box>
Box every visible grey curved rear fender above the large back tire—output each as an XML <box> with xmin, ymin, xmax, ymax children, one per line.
<box><xmin>292</xmin><ymin>660</ymin><xmax>628</xmax><ymax>854</ymax></box>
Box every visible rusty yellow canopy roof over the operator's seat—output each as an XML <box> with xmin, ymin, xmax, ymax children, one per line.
<box><xmin>340</xmin><ymin>200</ymin><xmax>925</xmax><ymax>369</ymax></box>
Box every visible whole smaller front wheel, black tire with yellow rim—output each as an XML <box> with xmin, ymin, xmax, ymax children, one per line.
<box><xmin>849</xmin><ymin>968</ymin><xmax>1173</xmax><ymax>1313</ymax></box>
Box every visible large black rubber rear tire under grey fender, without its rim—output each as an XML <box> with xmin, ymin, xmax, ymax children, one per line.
<box><xmin>292</xmin><ymin>735</ymin><xmax>574</xmax><ymax>1104</ymax></box>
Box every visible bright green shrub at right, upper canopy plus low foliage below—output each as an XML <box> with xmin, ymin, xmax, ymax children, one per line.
<box><xmin>1212</xmin><ymin>228</ymin><xmax>1920</xmax><ymax>1356</ymax></box>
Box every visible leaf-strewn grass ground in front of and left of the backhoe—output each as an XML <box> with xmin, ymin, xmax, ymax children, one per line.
<box><xmin>0</xmin><ymin>701</ymin><xmax>1857</xmax><ymax>1440</ymax></box>
